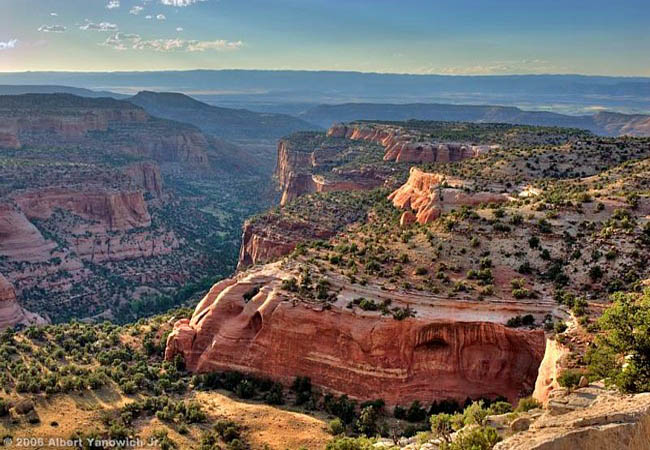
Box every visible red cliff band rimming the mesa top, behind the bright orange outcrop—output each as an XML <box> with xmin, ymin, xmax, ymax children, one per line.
<box><xmin>328</xmin><ymin>124</ymin><xmax>493</xmax><ymax>163</ymax></box>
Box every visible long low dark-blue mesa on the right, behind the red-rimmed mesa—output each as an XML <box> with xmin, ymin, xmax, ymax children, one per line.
<box><xmin>300</xmin><ymin>103</ymin><xmax>650</xmax><ymax>136</ymax></box>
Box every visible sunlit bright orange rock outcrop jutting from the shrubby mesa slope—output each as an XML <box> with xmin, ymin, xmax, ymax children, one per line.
<box><xmin>388</xmin><ymin>167</ymin><xmax>509</xmax><ymax>223</ymax></box>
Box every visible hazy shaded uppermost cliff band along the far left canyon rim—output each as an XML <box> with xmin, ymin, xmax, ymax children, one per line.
<box><xmin>0</xmin><ymin>94</ymin><xmax>209</xmax><ymax>167</ymax></box>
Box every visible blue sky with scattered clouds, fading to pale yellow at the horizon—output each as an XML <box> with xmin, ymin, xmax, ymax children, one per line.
<box><xmin>0</xmin><ymin>0</ymin><xmax>650</xmax><ymax>76</ymax></box>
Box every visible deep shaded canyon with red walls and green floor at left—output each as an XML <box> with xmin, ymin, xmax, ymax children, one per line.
<box><xmin>0</xmin><ymin>94</ymin><xmax>271</xmax><ymax>321</ymax></box>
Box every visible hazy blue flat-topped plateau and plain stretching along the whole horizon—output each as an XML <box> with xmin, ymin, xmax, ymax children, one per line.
<box><xmin>0</xmin><ymin>70</ymin><xmax>650</xmax><ymax>114</ymax></box>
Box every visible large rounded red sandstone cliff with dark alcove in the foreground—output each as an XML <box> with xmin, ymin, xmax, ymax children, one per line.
<box><xmin>165</xmin><ymin>264</ymin><xmax>544</xmax><ymax>405</ymax></box>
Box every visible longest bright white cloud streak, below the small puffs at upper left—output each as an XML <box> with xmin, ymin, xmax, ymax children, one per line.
<box><xmin>102</xmin><ymin>33</ymin><xmax>244</xmax><ymax>52</ymax></box>
